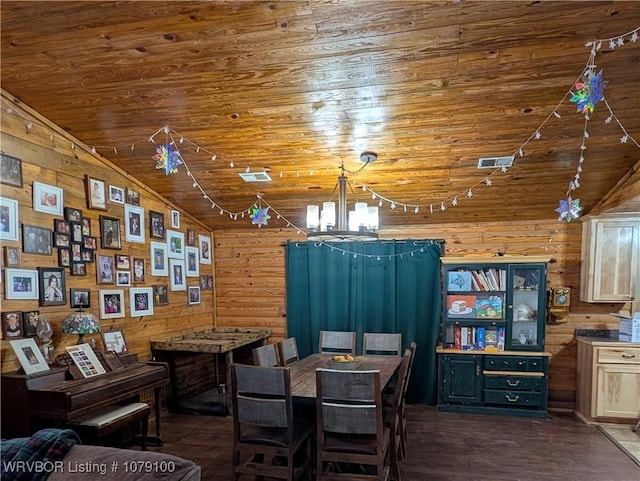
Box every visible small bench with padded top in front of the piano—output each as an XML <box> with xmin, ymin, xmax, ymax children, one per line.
<box><xmin>68</xmin><ymin>403</ymin><xmax>151</xmax><ymax>451</ymax></box>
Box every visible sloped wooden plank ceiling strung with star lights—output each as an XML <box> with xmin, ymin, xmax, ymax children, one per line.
<box><xmin>1</xmin><ymin>0</ymin><xmax>640</xmax><ymax>229</ymax></box>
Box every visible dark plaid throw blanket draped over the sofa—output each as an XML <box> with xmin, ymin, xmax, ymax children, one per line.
<box><xmin>0</xmin><ymin>429</ymin><xmax>80</xmax><ymax>481</ymax></box>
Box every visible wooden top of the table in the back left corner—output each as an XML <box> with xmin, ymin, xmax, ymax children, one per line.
<box><xmin>150</xmin><ymin>328</ymin><xmax>271</xmax><ymax>354</ymax></box>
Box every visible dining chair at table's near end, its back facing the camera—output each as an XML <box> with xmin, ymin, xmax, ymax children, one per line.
<box><xmin>316</xmin><ymin>369</ymin><xmax>390</xmax><ymax>481</ymax></box>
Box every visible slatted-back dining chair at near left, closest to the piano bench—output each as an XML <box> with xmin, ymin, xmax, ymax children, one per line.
<box><xmin>231</xmin><ymin>364</ymin><xmax>314</xmax><ymax>481</ymax></box>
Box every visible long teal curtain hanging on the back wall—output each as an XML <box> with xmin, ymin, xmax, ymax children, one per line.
<box><xmin>285</xmin><ymin>240</ymin><xmax>443</xmax><ymax>404</ymax></box>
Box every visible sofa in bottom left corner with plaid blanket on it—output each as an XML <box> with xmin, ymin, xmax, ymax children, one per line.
<box><xmin>0</xmin><ymin>429</ymin><xmax>201</xmax><ymax>481</ymax></box>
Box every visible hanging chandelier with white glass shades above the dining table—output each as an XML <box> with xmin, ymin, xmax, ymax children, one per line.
<box><xmin>307</xmin><ymin>152</ymin><xmax>378</xmax><ymax>241</ymax></box>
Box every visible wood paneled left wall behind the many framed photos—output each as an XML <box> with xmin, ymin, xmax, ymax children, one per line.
<box><xmin>0</xmin><ymin>94</ymin><xmax>215</xmax><ymax>372</ymax></box>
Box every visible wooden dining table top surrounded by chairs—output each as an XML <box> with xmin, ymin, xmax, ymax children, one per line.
<box><xmin>289</xmin><ymin>354</ymin><xmax>402</xmax><ymax>399</ymax></box>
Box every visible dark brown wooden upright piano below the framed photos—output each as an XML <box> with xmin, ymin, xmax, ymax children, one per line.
<box><xmin>1</xmin><ymin>362</ymin><xmax>169</xmax><ymax>438</ymax></box>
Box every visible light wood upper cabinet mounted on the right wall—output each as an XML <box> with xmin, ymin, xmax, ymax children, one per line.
<box><xmin>580</xmin><ymin>214</ymin><xmax>640</xmax><ymax>302</ymax></box>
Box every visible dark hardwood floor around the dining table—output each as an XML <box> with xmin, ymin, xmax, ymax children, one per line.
<box><xmin>149</xmin><ymin>404</ymin><xmax>640</xmax><ymax>481</ymax></box>
